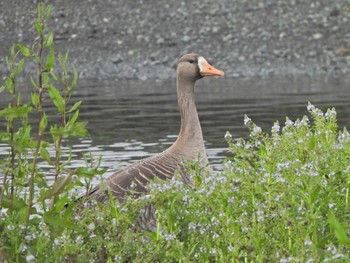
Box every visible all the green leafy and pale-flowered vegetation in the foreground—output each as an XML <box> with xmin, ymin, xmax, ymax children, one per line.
<box><xmin>0</xmin><ymin>4</ymin><xmax>350</xmax><ymax>262</ymax></box>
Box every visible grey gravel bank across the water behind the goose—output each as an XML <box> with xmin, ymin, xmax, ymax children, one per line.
<box><xmin>0</xmin><ymin>0</ymin><xmax>350</xmax><ymax>80</ymax></box>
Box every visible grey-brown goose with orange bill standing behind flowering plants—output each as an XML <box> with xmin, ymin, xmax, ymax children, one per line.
<box><xmin>87</xmin><ymin>54</ymin><xmax>224</xmax><ymax>202</ymax></box>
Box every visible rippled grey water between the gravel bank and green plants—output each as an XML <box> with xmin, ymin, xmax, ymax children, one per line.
<box><xmin>0</xmin><ymin>77</ymin><xmax>350</xmax><ymax>180</ymax></box>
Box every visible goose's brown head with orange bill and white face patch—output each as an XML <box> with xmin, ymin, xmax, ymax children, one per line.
<box><xmin>177</xmin><ymin>54</ymin><xmax>224</xmax><ymax>82</ymax></box>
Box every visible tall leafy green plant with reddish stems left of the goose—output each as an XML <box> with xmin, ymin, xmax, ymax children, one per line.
<box><xmin>0</xmin><ymin>3</ymin><xmax>104</xmax><ymax>261</ymax></box>
